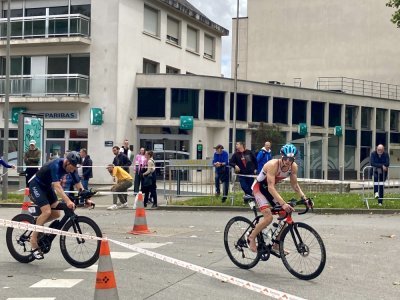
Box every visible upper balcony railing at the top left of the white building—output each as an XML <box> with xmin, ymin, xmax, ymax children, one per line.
<box><xmin>0</xmin><ymin>14</ymin><xmax>90</xmax><ymax>39</ymax></box>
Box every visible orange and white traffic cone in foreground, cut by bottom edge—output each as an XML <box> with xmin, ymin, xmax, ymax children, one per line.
<box><xmin>94</xmin><ymin>240</ymin><xmax>119</xmax><ymax>300</ymax></box>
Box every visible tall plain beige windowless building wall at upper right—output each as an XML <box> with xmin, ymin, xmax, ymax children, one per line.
<box><xmin>232</xmin><ymin>0</ymin><xmax>400</xmax><ymax>88</ymax></box>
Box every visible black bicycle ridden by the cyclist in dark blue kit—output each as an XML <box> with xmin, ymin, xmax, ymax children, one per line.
<box><xmin>6</xmin><ymin>190</ymin><xmax>102</xmax><ymax>268</ymax></box>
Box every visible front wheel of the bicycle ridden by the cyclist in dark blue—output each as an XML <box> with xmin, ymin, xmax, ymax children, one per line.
<box><xmin>60</xmin><ymin>216</ymin><xmax>102</xmax><ymax>268</ymax></box>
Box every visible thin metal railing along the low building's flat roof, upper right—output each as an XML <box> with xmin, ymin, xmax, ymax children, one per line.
<box><xmin>317</xmin><ymin>77</ymin><xmax>400</xmax><ymax>100</ymax></box>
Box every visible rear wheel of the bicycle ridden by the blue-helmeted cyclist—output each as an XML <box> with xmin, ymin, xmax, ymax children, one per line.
<box><xmin>224</xmin><ymin>216</ymin><xmax>261</xmax><ymax>269</ymax></box>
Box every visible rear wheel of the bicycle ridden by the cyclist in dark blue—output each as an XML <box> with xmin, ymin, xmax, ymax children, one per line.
<box><xmin>6</xmin><ymin>214</ymin><xmax>35</xmax><ymax>263</ymax></box>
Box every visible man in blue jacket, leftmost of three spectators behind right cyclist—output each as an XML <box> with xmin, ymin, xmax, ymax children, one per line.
<box><xmin>213</xmin><ymin>145</ymin><xmax>229</xmax><ymax>203</ymax></box>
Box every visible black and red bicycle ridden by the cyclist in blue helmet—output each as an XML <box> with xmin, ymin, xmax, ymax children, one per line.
<box><xmin>224</xmin><ymin>195</ymin><xmax>326</xmax><ymax>280</ymax></box>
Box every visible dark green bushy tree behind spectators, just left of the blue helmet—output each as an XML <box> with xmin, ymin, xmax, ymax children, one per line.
<box><xmin>251</xmin><ymin>122</ymin><xmax>286</xmax><ymax>155</ymax></box>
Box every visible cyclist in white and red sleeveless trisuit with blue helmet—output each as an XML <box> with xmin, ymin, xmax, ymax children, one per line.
<box><xmin>248</xmin><ymin>144</ymin><xmax>306</xmax><ymax>252</ymax></box>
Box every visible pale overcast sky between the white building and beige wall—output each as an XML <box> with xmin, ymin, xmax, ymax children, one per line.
<box><xmin>188</xmin><ymin>0</ymin><xmax>247</xmax><ymax>77</ymax></box>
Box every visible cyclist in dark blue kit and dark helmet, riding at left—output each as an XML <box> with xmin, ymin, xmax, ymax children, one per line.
<box><xmin>29</xmin><ymin>151</ymin><xmax>84</xmax><ymax>259</ymax></box>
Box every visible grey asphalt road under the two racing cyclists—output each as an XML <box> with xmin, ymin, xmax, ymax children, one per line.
<box><xmin>0</xmin><ymin>206</ymin><xmax>400</xmax><ymax>300</ymax></box>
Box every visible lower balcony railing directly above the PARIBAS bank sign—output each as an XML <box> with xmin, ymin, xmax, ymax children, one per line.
<box><xmin>0</xmin><ymin>74</ymin><xmax>89</xmax><ymax>97</ymax></box>
